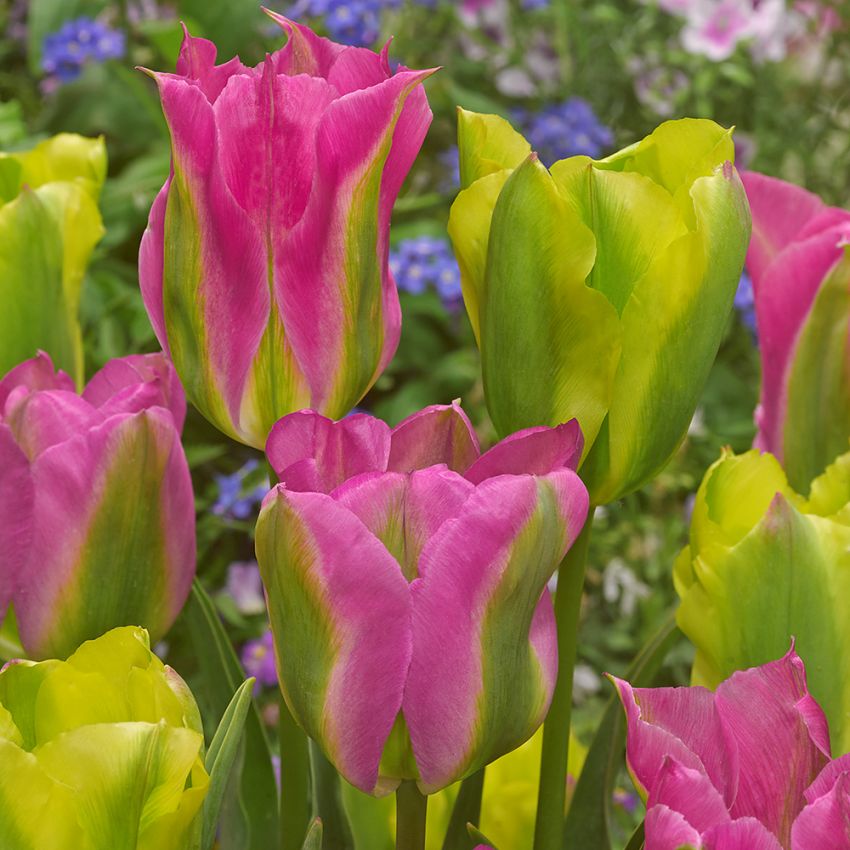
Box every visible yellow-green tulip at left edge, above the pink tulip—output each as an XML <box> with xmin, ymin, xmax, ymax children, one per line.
<box><xmin>0</xmin><ymin>133</ymin><xmax>106</xmax><ymax>382</ymax></box>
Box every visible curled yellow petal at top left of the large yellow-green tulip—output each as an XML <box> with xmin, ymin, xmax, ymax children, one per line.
<box><xmin>457</xmin><ymin>107</ymin><xmax>531</xmax><ymax>189</ymax></box>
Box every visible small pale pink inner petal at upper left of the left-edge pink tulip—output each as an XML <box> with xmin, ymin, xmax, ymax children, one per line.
<box><xmin>6</xmin><ymin>390</ymin><xmax>104</xmax><ymax>460</ymax></box>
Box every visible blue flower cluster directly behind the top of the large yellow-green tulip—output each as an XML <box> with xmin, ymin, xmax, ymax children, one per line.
<box><xmin>514</xmin><ymin>97</ymin><xmax>614</xmax><ymax>165</ymax></box>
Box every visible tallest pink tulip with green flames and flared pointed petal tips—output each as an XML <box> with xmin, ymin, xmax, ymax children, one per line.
<box><xmin>139</xmin><ymin>13</ymin><xmax>438</xmax><ymax>448</ymax></box>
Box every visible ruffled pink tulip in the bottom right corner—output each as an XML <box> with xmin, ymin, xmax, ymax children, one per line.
<box><xmin>612</xmin><ymin>647</ymin><xmax>850</xmax><ymax>850</ymax></box>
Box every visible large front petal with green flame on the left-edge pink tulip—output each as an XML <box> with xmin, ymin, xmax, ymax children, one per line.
<box><xmin>14</xmin><ymin>408</ymin><xmax>195</xmax><ymax>658</ymax></box>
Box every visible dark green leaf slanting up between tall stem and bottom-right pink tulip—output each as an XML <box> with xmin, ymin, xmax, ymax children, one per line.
<box><xmin>563</xmin><ymin>611</ymin><xmax>681</xmax><ymax>850</ymax></box>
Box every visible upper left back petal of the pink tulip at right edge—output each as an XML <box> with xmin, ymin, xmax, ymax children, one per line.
<box><xmin>741</xmin><ymin>171</ymin><xmax>826</xmax><ymax>289</ymax></box>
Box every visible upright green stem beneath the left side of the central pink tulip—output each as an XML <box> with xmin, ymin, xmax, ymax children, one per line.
<box><xmin>277</xmin><ymin>698</ymin><xmax>311</xmax><ymax>850</ymax></box>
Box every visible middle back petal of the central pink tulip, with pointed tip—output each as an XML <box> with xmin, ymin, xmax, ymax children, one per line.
<box><xmin>387</xmin><ymin>403</ymin><xmax>481</xmax><ymax>474</ymax></box>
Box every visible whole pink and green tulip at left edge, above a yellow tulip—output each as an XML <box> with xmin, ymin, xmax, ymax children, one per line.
<box><xmin>0</xmin><ymin>353</ymin><xmax>195</xmax><ymax>658</ymax></box>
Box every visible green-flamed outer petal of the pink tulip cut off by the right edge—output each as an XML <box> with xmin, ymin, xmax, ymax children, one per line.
<box><xmin>782</xmin><ymin>248</ymin><xmax>850</xmax><ymax>493</ymax></box>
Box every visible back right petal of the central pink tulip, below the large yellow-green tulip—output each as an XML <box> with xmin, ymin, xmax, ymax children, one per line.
<box><xmin>466</xmin><ymin>419</ymin><xmax>584</xmax><ymax>484</ymax></box>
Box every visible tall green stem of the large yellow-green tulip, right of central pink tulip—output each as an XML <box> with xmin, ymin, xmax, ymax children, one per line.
<box><xmin>534</xmin><ymin>509</ymin><xmax>593</xmax><ymax>850</ymax></box>
